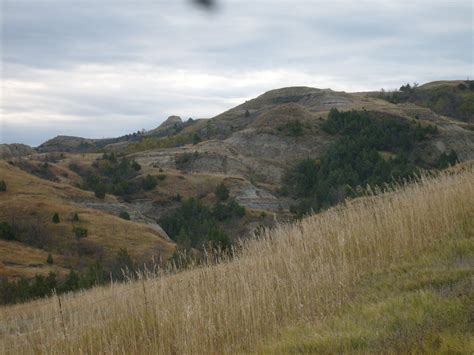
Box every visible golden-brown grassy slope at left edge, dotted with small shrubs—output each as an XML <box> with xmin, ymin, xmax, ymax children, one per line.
<box><xmin>0</xmin><ymin>161</ymin><xmax>174</xmax><ymax>278</ymax></box>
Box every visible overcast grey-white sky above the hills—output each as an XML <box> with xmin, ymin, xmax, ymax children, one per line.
<box><xmin>0</xmin><ymin>0</ymin><xmax>474</xmax><ymax>146</ymax></box>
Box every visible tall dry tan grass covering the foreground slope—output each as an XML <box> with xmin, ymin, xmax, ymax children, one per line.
<box><xmin>0</xmin><ymin>168</ymin><xmax>474</xmax><ymax>354</ymax></box>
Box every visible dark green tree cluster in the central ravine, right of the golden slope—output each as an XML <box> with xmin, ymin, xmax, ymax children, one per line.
<box><xmin>160</xmin><ymin>184</ymin><xmax>245</xmax><ymax>250</ymax></box>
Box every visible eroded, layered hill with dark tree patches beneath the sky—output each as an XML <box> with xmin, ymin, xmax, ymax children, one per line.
<box><xmin>0</xmin><ymin>82</ymin><xmax>474</xmax><ymax>286</ymax></box>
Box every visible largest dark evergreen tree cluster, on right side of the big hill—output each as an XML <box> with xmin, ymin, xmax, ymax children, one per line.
<box><xmin>282</xmin><ymin>109</ymin><xmax>437</xmax><ymax>215</ymax></box>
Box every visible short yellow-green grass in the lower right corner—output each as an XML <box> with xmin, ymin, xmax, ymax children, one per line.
<box><xmin>259</xmin><ymin>220</ymin><xmax>474</xmax><ymax>354</ymax></box>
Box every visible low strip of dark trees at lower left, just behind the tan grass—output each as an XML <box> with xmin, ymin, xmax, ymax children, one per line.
<box><xmin>0</xmin><ymin>249</ymin><xmax>140</xmax><ymax>304</ymax></box>
